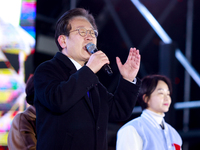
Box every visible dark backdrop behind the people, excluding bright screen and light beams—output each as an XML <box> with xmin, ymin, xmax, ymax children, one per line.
<box><xmin>33</xmin><ymin>0</ymin><xmax>200</xmax><ymax>150</ymax></box>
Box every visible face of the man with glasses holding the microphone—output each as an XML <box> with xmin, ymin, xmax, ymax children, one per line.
<box><xmin>62</xmin><ymin>17</ymin><xmax>97</xmax><ymax>66</ymax></box>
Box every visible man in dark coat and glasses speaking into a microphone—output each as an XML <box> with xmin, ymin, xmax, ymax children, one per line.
<box><xmin>34</xmin><ymin>8</ymin><xmax>141</xmax><ymax>150</ymax></box>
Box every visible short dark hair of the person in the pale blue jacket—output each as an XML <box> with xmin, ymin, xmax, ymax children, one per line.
<box><xmin>138</xmin><ymin>75</ymin><xmax>172</xmax><ymax>110</ymax></box>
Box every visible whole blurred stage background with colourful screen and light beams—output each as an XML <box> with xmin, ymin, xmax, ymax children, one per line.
<box><xmin>0</xmin><ymin>0</ymin><xmax>200</xmax><ymax>150</ymax></box>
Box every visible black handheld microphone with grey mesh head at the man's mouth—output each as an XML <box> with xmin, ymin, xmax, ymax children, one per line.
<box><xmin>86</xmin><ymin>43</ymin><xmax>113</xmax><ymax>76</ymax></box>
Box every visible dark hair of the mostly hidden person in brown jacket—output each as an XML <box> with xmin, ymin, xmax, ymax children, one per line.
<box><xmin>25</xmin><ymin>74</ymin><xmax>35</xmax><ymax>105</ymax></box>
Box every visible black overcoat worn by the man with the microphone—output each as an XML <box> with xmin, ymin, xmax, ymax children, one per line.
<box><xmin>34</xmin><ymin>52</ymin><xmax>141</xmax><ymax>150</ymax></box>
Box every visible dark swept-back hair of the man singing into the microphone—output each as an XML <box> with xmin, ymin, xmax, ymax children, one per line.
<box><xmin>55</xmin><ymin>8</ymin><xmax>97</xmax><ymax>51</ymax></box>
